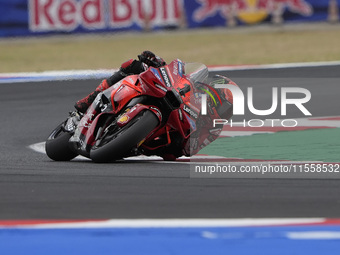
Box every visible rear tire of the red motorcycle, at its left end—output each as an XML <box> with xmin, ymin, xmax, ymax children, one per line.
<box><xmin>45</xmin><ymin>124</ymin><xmax>78</xmax><ymax>161</ymax></box>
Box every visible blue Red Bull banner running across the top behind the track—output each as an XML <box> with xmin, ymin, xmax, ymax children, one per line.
<box><xmin>0</xmin><ymin>0</ymin><xmax>340</xmax><ymax>37</ymax></box>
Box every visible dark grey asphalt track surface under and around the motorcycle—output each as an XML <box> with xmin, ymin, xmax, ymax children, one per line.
<box><xmin>0</xmin><ymin>66</ymin><xmax>340</xmax><ymax>220</ymax></box>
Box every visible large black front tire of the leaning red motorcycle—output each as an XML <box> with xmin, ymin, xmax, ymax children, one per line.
<box><xmin>90</xmin><ymin>110</ymin><xmax>159</xmax><ymax>163</ymax></box>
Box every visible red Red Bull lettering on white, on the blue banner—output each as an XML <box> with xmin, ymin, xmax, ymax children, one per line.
<box><xmin>28</xmin><ymin>0</ymin><xmax>183</xmax><ymax>32</ymax></box>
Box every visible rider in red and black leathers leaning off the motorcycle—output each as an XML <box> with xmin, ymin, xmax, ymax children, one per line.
<box><xmin>74</xmin><ymin>51</ymin><xmax>237</xmax><ymax>160</ymax></box>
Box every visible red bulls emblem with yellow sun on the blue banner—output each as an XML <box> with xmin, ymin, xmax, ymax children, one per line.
<box><xmin>193</xmin><ymin>0</ymin><xmax>313</xmax><ymax>24</ymax></box>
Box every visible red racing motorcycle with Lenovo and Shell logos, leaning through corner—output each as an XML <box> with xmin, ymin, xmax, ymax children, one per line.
<box><xmin>45</xmin><ymin>59</ymin><xmax>232</xmax><ymax>162</ymax></box>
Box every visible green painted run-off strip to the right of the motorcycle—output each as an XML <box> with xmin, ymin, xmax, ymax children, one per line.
<box><xmin>200</xmin><ymin>128</ymin><xmax>340</xmax><ymax>162</ymax></box>
